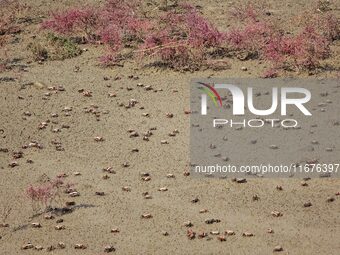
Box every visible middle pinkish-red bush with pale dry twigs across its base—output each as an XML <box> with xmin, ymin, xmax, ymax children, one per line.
<box><xmin>139</xmin><ymin>5</ymin><xmax>223</xmax><ymax>69</ymax></box>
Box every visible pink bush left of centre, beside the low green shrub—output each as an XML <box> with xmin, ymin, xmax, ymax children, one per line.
<box><xmin>42</xmin><ymin>0</ymin><xmax>149</xmax><ymax>64</ymax></box>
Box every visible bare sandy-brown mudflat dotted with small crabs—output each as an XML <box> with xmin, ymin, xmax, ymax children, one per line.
<box><xmin>0</xmin><ymin>0</ymin><xmax>340</xmax><ymax>255</ymax></box>
